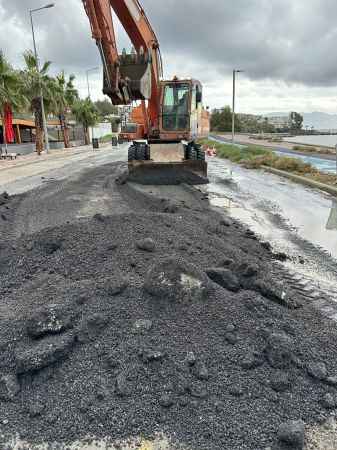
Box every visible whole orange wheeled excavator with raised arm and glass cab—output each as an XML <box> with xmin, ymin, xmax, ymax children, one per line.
<box><xmin>82</xmin><ymin>0</ymin><xmax>209</xmax><ymax>183</ymax></box>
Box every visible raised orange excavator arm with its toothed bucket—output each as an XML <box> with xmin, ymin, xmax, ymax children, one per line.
<box><xmin>82</xmin><ymin>0</ymin><xmax>162</xmax><ymax>130</ymax></box>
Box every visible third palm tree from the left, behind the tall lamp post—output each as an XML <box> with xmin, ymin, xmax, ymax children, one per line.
<box><xmin>51</xmin><ymin>71</ymin><xmax>78</xmax><ymax>148</ymax></box>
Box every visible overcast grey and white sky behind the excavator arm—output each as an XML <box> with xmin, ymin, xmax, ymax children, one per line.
<box><xmin>0</xmin><ymin>0</ymin><xmax>337</xmax><ymax>114</ymax></box>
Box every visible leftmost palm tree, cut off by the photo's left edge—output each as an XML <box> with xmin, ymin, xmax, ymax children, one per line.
<box><xmin>0</xmin><ymin>52</ymin><xmax>26</xmax><ymax>148</ymax></box>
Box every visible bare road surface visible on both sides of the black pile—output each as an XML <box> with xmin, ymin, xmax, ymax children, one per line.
<box><xmin>0</xmin><ymin>145</ymin><xmax>337</xmax><ymax>450</ymax></box>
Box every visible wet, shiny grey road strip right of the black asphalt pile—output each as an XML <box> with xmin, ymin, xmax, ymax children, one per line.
<box><xmin>206</xmin><ymin>158</ymin><xmax>337</xmax><ymax>301</ymax></box>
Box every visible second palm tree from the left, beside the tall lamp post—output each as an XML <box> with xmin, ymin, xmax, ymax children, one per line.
<box><xmin>22</xmin><ymin>50</ymin><xmax>52</xmax><ymax>155</ymax></box>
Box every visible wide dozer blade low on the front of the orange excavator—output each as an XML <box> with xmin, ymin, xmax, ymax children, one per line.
<box><xmin>128</xmin><ymin>144</ymin><xmax>208</xmax><ymax>185</ymax></box>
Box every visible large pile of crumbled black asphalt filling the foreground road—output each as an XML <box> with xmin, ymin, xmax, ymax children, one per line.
<box><xmin>0</xmin><ymin>177</ymin><xmax>337</xmax><ymax>450</ymax></box>
